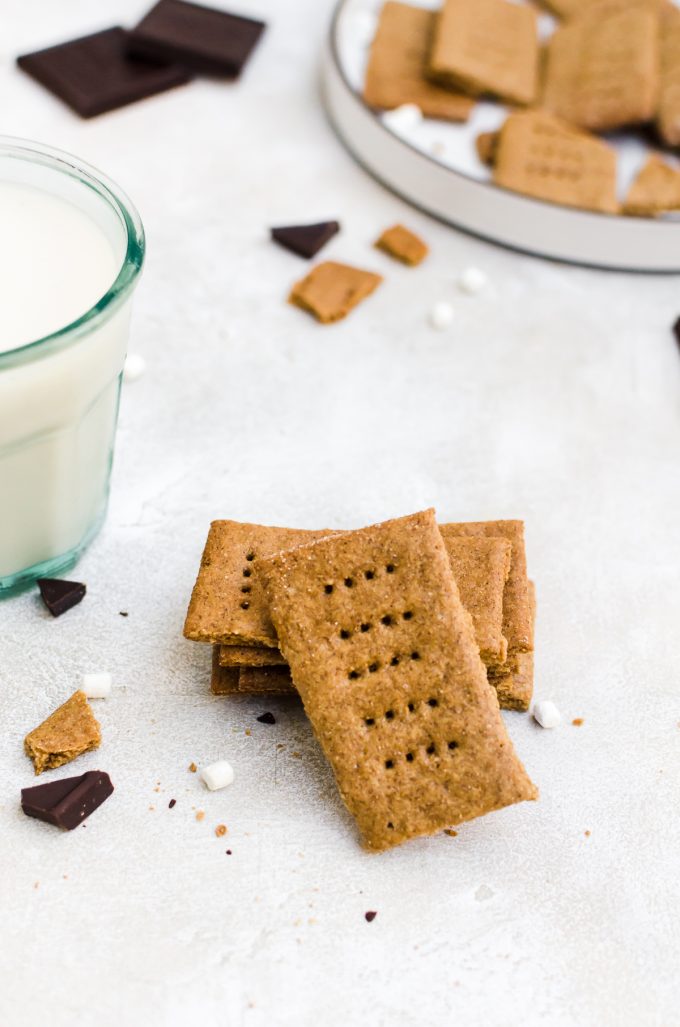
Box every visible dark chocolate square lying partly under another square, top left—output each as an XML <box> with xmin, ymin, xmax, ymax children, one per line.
<box><xmin>16</xmin><ymin>28</ymin><xmax>191</xmax><ymax>118</ymax></box>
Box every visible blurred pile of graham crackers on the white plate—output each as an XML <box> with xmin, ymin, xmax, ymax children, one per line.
<box><xmin>364</xmin><ymin>0</ymin><xmax>680</xmax><ymax>217</ymax></box>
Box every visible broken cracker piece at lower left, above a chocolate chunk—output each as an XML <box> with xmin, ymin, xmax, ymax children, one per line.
<box><xmin>24</xmin><ymin>691</ymin><xmax>102</xmax><ymax>774</ymax></box>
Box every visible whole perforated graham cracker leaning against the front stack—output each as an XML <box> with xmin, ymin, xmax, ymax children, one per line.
<box><xmin>260</xmin><ymin>510</ymin><xmax>537</xmax><ymax>850</ymax></box>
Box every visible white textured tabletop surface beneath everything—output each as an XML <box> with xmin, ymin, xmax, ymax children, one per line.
<box><xmin>0</xmin><ymin>0</ymin><xmax>680</xmax><ymax>1027</ymax></box>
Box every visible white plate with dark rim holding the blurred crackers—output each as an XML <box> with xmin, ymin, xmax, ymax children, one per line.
<box><xmin>324</xmin><ymin>0</ymin><xmax>680</xmax><ymax>272</ymax></box>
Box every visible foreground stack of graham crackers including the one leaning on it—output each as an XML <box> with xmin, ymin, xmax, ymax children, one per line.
<box><xmin>184</xmin><ymin>509</ymin><xmax>537</xmax><ymax>850</ymax></box>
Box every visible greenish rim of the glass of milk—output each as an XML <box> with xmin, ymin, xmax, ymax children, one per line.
<box><xmin>0</xmin><ymin>136</ymin><xmax>146</xmax><ymax>371</ymax></box>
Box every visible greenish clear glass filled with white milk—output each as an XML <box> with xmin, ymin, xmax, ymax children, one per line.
<box><xmin>0</xmin><ymin>138</ymin><xmax>144</xmax><ymax>596</ymax></box>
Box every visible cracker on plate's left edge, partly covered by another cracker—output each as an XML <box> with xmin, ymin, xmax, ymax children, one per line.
<box><xmin>364</xmin><ymin>0</ymin><xmax>475</xmax><ymax>121</ymax></box>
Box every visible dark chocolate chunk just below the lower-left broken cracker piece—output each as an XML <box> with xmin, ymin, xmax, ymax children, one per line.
<box><xmin>22</xmin><ymin>770</ymin><xmax>113</xmax><ymax>831</ymax></box>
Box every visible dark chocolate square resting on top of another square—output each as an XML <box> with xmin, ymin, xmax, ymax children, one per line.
<box><xmin>128</xmin><ymin>0</ymin><xmax>265</xmax><ymax>78</ymax></box>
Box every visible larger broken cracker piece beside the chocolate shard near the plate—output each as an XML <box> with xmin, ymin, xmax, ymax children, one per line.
<box><xmin>289</xmin><ymin>261</ymin><xmax>382</xmax><ymax>325</ymax></box>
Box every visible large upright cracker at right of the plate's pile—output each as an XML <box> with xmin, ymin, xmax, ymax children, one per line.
<box><xmin>542</xmin><ymin>7</ymin><xmax>659</xmax><ymax>131</ymax></box>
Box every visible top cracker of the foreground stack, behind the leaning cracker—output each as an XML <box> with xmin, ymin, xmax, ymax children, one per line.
<box><xmin>184</xmin><ymin>521</ymin><xmax>511</xmax><ymax>665</ymax></box>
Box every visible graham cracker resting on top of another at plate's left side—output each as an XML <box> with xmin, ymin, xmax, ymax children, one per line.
<box><xmin>428</xmin><ymin>0</ymin><xmax>538</xmax><ymax>105</ymax></box>
